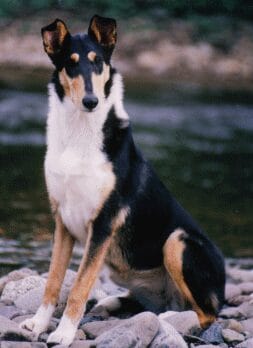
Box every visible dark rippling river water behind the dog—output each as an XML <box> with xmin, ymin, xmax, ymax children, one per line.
<box><xmin>0</xmin><ymin>90</ymin><xmax>253</xmax><ymax>273</ymax></box>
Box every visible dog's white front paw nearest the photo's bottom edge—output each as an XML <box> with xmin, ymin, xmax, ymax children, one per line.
<box><xmin>47</xmin><ymin>314</ymin><xmax>78</xmax><ymax>346</ymax></box>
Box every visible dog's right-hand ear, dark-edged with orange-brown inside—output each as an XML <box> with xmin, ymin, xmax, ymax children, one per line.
<box><xmin>88</xmin><ymin>15</ymin><xmax>117</xmax><ymax>52</ymax></box>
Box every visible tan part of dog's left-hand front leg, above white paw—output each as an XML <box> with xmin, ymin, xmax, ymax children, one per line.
<box><xmin>43</xmin><ymin>214</ymin><xmax>74</xmax><ymax>306</ymax></box>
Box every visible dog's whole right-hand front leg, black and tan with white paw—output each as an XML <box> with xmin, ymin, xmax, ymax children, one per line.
<box><xmin>47</xmin><ymin>222</ymin><xmax>111</xmax><ymax>345</ymax></box>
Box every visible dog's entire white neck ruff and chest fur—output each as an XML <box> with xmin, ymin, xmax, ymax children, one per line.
<box><xmin>45</xmin><ymin>75</ymin><xmax>127</xmax><ymax>243</ymax></box>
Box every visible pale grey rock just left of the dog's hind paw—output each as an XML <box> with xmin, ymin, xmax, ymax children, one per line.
<box><xmin>162</xmin><ymin>311</ymin><xmax>201</xmax><ymax>335</ymax></box>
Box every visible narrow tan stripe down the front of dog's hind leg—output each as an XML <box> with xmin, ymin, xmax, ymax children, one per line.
<box><xmin>163</xmin><ymin>229</ymin><xmax>215</xmax><ymax>327</ymax></box>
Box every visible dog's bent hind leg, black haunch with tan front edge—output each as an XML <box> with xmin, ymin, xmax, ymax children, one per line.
<box><xmin>163</xmin><ymin>229</ymin><xmax>225</xmax><ymax>327</ymax></box>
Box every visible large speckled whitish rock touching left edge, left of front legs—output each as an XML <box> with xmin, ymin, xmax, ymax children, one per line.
<box><xmin>1</xmin><ymin>275</ymin><xmax>46</xmax><ymax>302</ymax></box>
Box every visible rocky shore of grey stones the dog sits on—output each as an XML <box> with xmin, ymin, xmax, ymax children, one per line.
<box><xmin>0</xmin><ymin>262</ymin><xmax>253</xmax><ymax>348</ymax></box>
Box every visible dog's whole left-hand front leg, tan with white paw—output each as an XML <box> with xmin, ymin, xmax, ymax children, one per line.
<box><xmin>20</xmin><ymin>215</ymin><xmax>74</xmax><ymax>336</ymax></box>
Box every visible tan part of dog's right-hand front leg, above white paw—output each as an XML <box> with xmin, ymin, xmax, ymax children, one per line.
<box><xmin>64</xmin><ymin>237</ymin><xmax>110</xmax><ymax>322</ymax></box>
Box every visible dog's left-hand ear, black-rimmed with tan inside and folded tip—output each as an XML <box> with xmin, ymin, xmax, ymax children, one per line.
<box><xmin>41</xmin><ymin>19</ymin><xmax>70</xmax><ymax>61</ymax></box>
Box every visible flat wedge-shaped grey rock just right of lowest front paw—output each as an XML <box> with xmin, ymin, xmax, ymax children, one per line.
<box><xmin>81</xmin><ymin>319</ymin><xmax>122</xmax><ymax>338</ymax></box>
